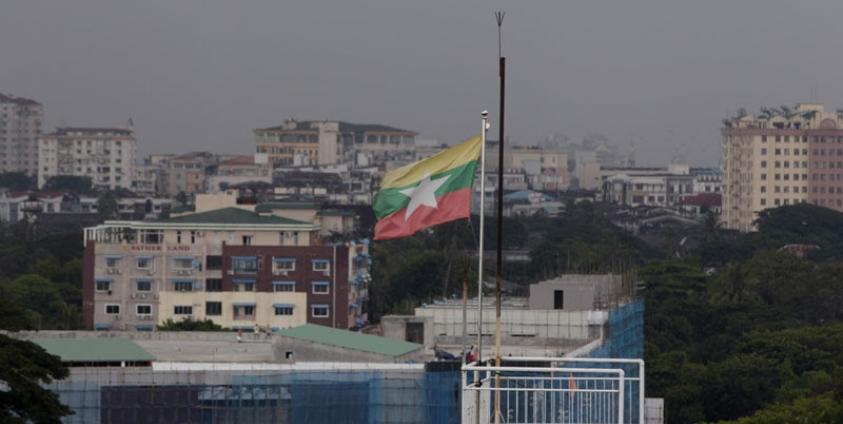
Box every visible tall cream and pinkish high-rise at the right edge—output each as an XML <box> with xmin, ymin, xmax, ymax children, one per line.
<box><xmin>721</xmin><ymin>103</ymin><xmax>843</xmax><ymax>231</ymax></box>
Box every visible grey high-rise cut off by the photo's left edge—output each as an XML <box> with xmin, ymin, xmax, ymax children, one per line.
<box><xmin>0</xmin><ymin>93</ymin><xmax>44</xmax><ymax>176</ymax></box>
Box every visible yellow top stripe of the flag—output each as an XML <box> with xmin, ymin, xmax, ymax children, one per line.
<box><xmin>381</xmin><ymin>136</ymin><xmax>481</xmax><ymax>189</ymax></box>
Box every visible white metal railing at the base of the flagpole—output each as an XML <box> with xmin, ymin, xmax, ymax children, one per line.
<box><xmin>462</xmin><ymin>357</ymin><xmax>644</xmax><ymax>424</ymax></box>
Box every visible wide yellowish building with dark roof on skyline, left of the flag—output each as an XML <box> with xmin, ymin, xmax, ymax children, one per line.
<box><xmin>254</xmin><ymin>119</ymin><xmax>417</xmax><ymax>167</ymax></box>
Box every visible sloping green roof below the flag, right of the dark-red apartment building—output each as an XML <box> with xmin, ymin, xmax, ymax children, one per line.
<box><xmin>276</xmin><ymin>324</ymin><xmax>423</xmax><ymax>356</ymax></box>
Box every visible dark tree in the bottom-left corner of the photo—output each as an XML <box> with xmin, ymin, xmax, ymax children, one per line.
<box><xmin>0</xmin><ymin>335</ymin><xmax>72</xmax><ymax>424</ymax></box>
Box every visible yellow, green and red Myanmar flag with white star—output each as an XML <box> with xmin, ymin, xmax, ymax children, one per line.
<box><xmin>372</xmin><ymin>136</ymin><xmax>482</xmax><ymax>240</ymax></box>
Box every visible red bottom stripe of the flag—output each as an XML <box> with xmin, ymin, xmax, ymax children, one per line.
<box><xmin>375</xmin><ymin>188</ymin><xmax>471</xmax><ymax>240</ymax></box>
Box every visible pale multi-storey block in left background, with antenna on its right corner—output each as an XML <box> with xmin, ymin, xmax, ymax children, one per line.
<box><xmin>38</xmin><ymin>127</ymin><xmax>137</xmax><ymax>189</ymax></box>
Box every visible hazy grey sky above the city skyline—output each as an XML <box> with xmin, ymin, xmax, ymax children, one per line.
<box><xmin>0</xmin><ymin>0</ymin><xmax>843</xmax><ymax>164</ymax></box>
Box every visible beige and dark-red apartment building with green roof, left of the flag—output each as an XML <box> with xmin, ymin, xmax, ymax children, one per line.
<box><xmin>83</xmin><ymin>207</ymin><xmax>369</xmax><ymax>331</ymax></box>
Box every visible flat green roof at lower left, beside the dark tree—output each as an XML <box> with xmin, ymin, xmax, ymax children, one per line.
<box><xmin>33</xmin><ymin>338</ymin><xmax>155</xmax><ymax>362</ymax></box>
